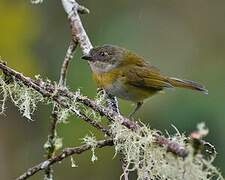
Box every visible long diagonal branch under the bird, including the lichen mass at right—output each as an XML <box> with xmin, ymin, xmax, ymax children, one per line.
<box><xmin>0</xmin><ymin>60</ymin><xmax>222</xmax><ymax>179</ymax></box>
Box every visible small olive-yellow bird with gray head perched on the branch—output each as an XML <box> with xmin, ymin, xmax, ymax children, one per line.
<box><xmin>82</xmin><ymin>45</ymin><xmax>208</xmax><ymax>116</ymax></box>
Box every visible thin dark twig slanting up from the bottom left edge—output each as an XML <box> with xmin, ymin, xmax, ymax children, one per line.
<box><xmin>16</xmin><ymin>139</ymin><xmax>113</xmax><ymax>180</ymax></box>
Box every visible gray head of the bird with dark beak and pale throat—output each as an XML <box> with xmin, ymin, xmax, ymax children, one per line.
<box><xmin>82</xmin><ymin>45</ymin><xmax>125</xmax><ymax>72</ymax></box>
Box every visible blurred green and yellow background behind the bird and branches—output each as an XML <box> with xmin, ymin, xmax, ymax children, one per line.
<box><xmin>0</xmin><ymin>0</ymin><xmax>225</xmax><ymax>180</ymax></box>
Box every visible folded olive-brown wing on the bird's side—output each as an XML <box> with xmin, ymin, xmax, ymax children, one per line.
<box><xmin>123</xmin><ymin>65</ymin><xmax>173</xmax><ymax>90</ymax></box>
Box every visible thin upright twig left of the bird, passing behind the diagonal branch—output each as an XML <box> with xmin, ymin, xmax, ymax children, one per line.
<box><xmin>45</xmin><ymin>0</ymin><xmax>92</xmax><ymax>179</ymax></box>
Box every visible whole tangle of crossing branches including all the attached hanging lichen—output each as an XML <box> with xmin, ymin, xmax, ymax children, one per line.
<box><xmin>0</xmin><ymin>0</ymin><xmax>223</xmax><ymax>180</ymax></box>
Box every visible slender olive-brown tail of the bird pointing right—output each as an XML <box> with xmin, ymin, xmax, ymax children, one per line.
<box><xmin>168</xmin><ymin>77</ymin><xmax>208</xmax><ymax>94</ymax></box>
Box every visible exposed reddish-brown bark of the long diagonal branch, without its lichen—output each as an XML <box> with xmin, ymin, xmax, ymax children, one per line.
<box><xmin>0</xmin><ymin>62</ymin><xmax>188</xmax><ymax>157</ymax></box>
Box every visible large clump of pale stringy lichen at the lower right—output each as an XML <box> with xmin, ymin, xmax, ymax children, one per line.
<box><xmin>111</xmin><ymin>122</ymin><xmax>223</xmax><ymax>180</ymax></box>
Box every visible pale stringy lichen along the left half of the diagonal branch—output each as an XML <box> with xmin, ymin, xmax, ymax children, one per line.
<box><xmin>0</xmin><ymin>75</ymin><xmax>104</xmax><ymax>123</ymax></box>
